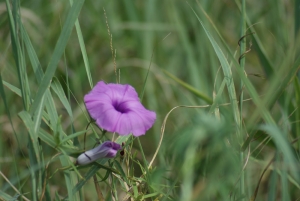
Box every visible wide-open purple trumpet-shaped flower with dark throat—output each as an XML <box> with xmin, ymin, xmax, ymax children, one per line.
<box><xmin>84</xmin><ymin>81</ymin><xmax>156</xmax><ymax>136</ymax></box>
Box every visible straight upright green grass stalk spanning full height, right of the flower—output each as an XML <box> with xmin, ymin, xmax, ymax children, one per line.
<box><xmin>239</xmin><ymin>0</ymin><xmax>246</xmax><ymax>201</ymax></box>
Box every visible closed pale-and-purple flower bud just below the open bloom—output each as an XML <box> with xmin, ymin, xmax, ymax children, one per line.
<box><xmin>76</xmin><ymin>141</ymin><xmax>122</xmax><ymax>165</ymax></box>
